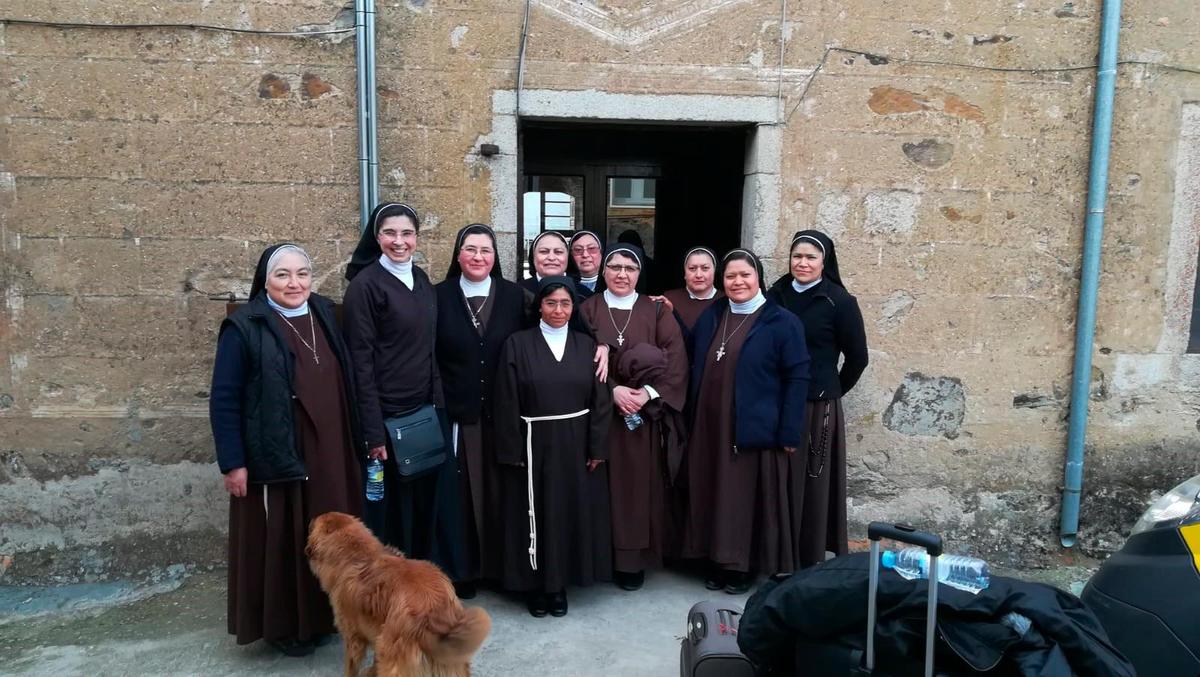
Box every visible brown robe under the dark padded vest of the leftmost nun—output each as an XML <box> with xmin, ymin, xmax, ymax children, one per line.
<box><xmin>228</xmin><ymin>316</ymin><xmax>364</xmax><ymax>645</ymax></box>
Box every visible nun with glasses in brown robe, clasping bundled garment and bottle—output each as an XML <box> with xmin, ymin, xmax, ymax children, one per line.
<box><xmin>580</xmin><ymin>245</ymin><xmax>688</xmax><ymax>591</ymax></box>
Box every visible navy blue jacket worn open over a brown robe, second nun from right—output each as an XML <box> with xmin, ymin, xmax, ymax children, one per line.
<box><xmin>688</xmin><ymin>298</ymin><xmax>809</xmax><ymax>451</ymax></box>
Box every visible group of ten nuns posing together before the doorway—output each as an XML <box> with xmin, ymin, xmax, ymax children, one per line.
<box><xmin>214</xmin><ymin>203</ymin><xmax>868</xmax><ymax>643</ymax></box>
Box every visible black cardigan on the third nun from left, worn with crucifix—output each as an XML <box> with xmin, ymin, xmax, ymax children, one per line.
<box><xmin>434</xmin><ymin>276</ymin><xmax>526</xmax><ymax>424</ymax></box>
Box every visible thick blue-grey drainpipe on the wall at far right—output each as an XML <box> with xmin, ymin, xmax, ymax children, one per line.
<box><xmin>1058</xmin><ymin>0</ymin><xmax>1121</xmax><ymax>547</ymax></box>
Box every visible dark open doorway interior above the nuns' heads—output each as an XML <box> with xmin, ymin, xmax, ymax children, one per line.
<box><xmin>520</xmin><ymin>122</ymin><xmax>748</xmax><ymax>292</ymax></box>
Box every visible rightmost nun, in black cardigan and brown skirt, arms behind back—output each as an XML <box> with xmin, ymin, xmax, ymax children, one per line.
<box><xmin>768</xmin><ymin>230</ymin><xmax>868</xmax><ymax>565</ymax></box>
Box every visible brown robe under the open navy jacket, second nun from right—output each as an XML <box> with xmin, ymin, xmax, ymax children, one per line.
<box><xmin>684</xmin><ymin>308</ymin><xmax>805</xmax><ymax>574</ymax></box>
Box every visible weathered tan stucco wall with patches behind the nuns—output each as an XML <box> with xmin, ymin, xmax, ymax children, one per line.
<box><xmin>0</xmin><ymin>0</ymin><xmax>1200</xmax><ymax>580</ymax></box>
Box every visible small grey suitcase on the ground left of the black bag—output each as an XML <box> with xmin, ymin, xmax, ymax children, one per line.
<box><xmin>679</xmin><ymin>601</ymin><xmax>755</xmax><ymax>677</ymax></box>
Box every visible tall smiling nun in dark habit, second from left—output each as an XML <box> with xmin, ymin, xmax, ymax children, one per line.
<box><xmin>343</xmin><ymin>203</ymin><xmax>468</xmax><ymax>581</ymax></box>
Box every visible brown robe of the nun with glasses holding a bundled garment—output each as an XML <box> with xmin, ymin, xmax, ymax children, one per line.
<box><xmin>580</xmin><ymin>294</ymin><xmax>688</xmax><ymax>573</ymax></box>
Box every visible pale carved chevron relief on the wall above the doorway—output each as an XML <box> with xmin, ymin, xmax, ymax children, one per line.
<box><xmin>536</xmin><ymin>0</ymin><xmax>754</xmax><ymax>47</ymax></box>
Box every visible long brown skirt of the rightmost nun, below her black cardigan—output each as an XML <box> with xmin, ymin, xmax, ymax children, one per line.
<box><xmin>797</xmin><ymin>399</ymin><xmax>847</xmax><ymax>567</ymax></box>
